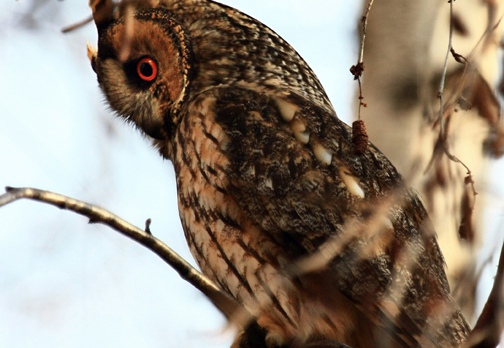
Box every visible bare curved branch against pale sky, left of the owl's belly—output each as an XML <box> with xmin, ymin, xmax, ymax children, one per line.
<box><xmin>0</xmin><ymin>187</ymin><xmax>242</xmax><ymax>318</ymax></box>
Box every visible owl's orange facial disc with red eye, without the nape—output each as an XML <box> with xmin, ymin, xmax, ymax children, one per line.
<box><xmin>90</xmin><ymin>1</ymin><xmax>193</xmax><ymax>139</ymax></box>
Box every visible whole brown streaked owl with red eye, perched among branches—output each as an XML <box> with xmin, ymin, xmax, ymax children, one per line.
<box><xmin>90</xmin><ymin>0</ymin><xmax>469</xmax><ymax>347</ymax></box>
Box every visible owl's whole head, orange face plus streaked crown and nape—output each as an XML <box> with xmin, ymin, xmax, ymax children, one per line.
<box><xmin>89</xmin><ymin>0</ymin><xmax>332</xmax><ymax>141</ymax></box>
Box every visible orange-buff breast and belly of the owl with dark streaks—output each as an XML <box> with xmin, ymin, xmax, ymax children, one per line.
<box><xmin>169</xmin><ymin>88</ymin><xmax>378</xmax><ymax>347</ymax></box>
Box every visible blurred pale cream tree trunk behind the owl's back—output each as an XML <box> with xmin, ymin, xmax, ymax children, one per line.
<box><xmin>362</xmin><ymin>0</ymin><xmax>503</xmax><ymax>320</ymax></box>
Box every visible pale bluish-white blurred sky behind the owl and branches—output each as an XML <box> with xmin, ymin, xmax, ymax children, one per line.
<box><xmin>0</xmin><ymin>0</ymin><xmax>504</xmax><ymax>347</ymax></box>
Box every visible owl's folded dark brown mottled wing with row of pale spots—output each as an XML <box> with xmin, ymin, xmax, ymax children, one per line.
<box><xmin>204</xmin><ymin>88</ymin><xmax>468</xmax><ymax>347</ymax></box>
